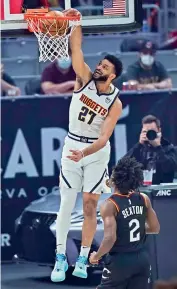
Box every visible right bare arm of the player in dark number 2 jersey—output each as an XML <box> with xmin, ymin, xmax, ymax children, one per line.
<box><xmin>141</xmin><ymin>193</ymin><xmax>160</xmax><ymax>234</ymax></box>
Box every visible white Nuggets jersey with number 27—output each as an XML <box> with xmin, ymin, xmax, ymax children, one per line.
<box><xmin>69</xmin><ymin>80</ymin><xmax>119</xmax><ymax>138</ymax></box>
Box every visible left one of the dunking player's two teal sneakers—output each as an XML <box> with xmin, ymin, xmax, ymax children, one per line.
<box><xmin>51</xmin><ymin>254</ymin><xmax>68</xmax><ymax>282</ymax></box>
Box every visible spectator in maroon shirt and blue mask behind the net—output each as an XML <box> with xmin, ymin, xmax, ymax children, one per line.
<box><xmin>41</xmin><ymin>54</ymin><xmax>76</xmax><ymax>94</ymax></box>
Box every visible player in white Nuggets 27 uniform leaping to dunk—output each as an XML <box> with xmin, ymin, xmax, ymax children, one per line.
<box><xmin>51</xmin><ymin>9</ymin><xmax>122</xmax><ymax>282</ymax></box>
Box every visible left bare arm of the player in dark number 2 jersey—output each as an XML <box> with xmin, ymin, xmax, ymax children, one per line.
<box><xmin>95</xmin><ymin>200</ymin><xmax>117</xmax><ymax>260</ymax></box>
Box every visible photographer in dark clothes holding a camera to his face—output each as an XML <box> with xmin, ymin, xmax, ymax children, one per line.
<box><xmin>124</xmin><ymin>115</ymin><xmax>177</xmax><ymax>184</ymax></box>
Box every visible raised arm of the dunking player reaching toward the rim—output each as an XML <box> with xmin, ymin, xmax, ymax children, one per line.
<box><xmin>70</xmin><ymin>26</ymin><xmax>92</xmax><ymax>90</ymax></box>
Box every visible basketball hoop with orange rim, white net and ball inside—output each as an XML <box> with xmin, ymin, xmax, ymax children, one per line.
<box><xmin>26</xmin><ymin>17</ymin><xmax>81</xmax><ymax>62</ymax></box>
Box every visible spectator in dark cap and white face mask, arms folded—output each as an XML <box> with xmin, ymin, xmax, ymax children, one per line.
<box><xmin>127</xmin><ymin>40</ymin><xmax>172</xmax><ymax>90</ymax></box>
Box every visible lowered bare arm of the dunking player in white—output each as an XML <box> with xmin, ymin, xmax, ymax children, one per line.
<box><xmin>83</xmin><ymin>99</ymin><xmax>122</xmax><ymax>157</ymax></box>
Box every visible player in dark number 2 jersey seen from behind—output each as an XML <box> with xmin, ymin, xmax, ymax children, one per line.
<box><xmin>90</xmin><ymin>157</ymin><xmax>160</xmax><ymax>289</ymax></box>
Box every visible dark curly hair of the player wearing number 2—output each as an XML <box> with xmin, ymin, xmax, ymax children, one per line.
<box><xmin>111</xmin><ymin>156</ymin><xmax>143</xmax><ymax>194</ymax></box>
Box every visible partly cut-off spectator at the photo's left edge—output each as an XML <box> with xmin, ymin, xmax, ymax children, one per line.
<box><xmin>1</xmin><ymin>63</ymin><xmax>21</xmax><ymax>96</ymax></box>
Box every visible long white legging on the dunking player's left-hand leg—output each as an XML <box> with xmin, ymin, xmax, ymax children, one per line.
<box><xmin>56</xmin><ymin>188</ymin><xmax>77</xmax><ymax>254</ymax></box>
